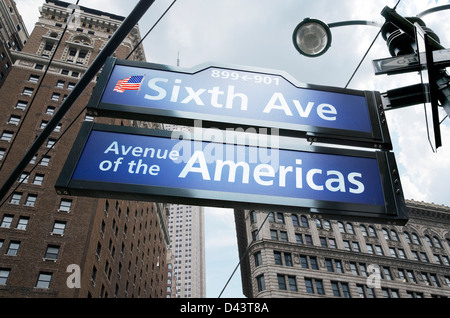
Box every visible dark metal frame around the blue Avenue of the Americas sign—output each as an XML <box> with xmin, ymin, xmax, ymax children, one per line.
<box><xmin>55</xmin><ymin>122</ymin><xmax>408</xmax><ymax>224</ymax></box>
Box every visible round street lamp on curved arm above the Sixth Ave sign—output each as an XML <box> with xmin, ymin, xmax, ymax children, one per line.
<box><xmin>292</xmin><ymin>18</ymin><xmax>381</xmax><ymax>57</ymax></box>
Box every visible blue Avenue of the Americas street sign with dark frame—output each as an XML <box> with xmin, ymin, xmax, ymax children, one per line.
<box><xmin>55</xmin><ymin>122</ymin><xmax>407</xmax><ymax>224</ymax></box>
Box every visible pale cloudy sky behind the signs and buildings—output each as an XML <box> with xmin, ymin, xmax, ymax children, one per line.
<box><xmin>16</xmin><ymin>0</ymin><xmax>450</xmax><ymax>298</ymax></box>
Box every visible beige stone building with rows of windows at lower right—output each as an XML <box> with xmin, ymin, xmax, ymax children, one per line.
<box><xmin>235</xmin><ymin>201</ymin><xmax>450</xmax><ymax>298</ymax></box>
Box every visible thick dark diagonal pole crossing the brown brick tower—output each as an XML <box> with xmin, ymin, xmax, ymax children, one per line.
<box><xmin>0</xmin><ymin>0</ymin><xmax>155</xmax><ymax>201</ymax></box>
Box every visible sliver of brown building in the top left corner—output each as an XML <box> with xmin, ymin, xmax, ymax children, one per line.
<box><xmin>0</xmin><ymin>0</ymin><xmax>28</xmax><ymax>87</ymax></box>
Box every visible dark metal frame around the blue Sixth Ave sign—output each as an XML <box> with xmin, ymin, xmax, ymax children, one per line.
<box><xmin>87</xmin><ymin>58</ymin><xmax>392</xmax><ymax>150</ymax></box>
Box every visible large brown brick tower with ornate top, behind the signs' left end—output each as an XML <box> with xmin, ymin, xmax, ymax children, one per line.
<box><xmin>0</xmin><ymin>0</ymin><xmax>169</xmax><ymax>297</ymax></box>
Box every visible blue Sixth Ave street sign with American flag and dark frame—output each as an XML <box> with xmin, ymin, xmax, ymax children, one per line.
<box><xmin>88</xmin><ymin>58</ymin><xmax>392</xmax><ymax>149</ymax></box>
